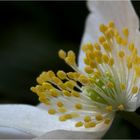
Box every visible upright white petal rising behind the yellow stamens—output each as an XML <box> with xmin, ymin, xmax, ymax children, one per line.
<box><xmin>78</xmin><ymin>0</ymin><xmax>139</xmax><ymax>69</ymax></box>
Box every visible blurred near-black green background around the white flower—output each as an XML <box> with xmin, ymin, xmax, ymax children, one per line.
<box><xmin>0</xmin><ymin>1</ymin><xmax>140</xmax><ymax>138</ymax></box>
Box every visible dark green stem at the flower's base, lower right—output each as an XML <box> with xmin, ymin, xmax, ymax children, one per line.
<box><xmin>118</xmin><ymin>111</ymin><xmax>140</xmax><ymax>129</ymax></box>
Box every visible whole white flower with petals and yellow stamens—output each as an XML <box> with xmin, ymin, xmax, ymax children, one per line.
<box><xmin>0</xmin><ymin>1</ymin><xmax>140</xmax><ymax>138</ymax></box>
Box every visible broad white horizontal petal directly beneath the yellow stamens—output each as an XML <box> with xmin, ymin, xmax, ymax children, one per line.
<box><xmin>0</xmin><ymin>105</ymin><xmax>114</xmax><ymax>138</ymax></box>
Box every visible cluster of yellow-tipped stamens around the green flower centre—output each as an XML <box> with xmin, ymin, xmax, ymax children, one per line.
<box><xmin>31</xmin><ymin>21</ymin><xmax>140</xmax><ymax>128</ymax></box>
